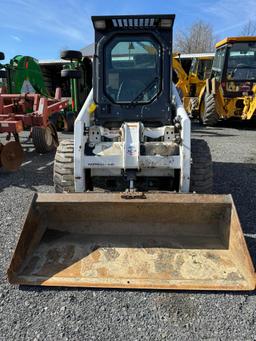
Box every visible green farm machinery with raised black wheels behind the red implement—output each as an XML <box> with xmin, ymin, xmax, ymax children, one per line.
<box><xmin>0</xmin><ymin>51</ymin><xmax>92</xmax><ymax>131</ymax></box>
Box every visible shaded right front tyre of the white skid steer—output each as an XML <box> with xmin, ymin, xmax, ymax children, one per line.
<box><xmin>190</xmin><ymin>139</ymin><xmax>213</xmax><ymax>194</ymax></box>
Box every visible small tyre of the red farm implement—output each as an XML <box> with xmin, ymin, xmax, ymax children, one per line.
<box><xmin>32</xmin><ymin>124</ymin><xmax>58</xmax><ymax>154</ymax></box>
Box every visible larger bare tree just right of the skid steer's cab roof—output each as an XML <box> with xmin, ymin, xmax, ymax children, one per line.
<box><xmin>174</xmin><ymin>20</ymin><xmax>215</xmax><ymax>53</ymax></box>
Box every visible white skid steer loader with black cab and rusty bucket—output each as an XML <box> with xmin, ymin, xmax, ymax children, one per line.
<box><xmin>8</xmin><ymin>15</ymin><xmax>255</xmax><ymax>290</ymax></box>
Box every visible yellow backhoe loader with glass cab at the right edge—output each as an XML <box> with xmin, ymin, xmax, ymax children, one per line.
<box><xmin>199</xmin><ymin>37</ymin><xmax>256</xmax><ymax>126</ymax></box>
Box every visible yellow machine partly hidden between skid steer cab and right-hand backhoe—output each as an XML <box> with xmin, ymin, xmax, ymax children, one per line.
<box><xmin>172</xmin><ymin>53</ymin><xmax>213</xmax><ymax>116</ymax></box>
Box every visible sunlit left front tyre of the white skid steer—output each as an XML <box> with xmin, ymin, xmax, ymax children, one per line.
<box><xmin>53</xmin><ymin>140</ymin><xmax>75</xmax><ymax>193</ymax></box>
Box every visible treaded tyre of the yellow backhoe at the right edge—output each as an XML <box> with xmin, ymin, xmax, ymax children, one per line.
<box><xmin>200</xmin><ymin>93</ymin><xmax>219</xmax><ymax>126</ymax></box>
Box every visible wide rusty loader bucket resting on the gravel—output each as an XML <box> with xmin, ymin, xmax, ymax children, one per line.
<box><xmin>8</xmin><ymin>193</ymin><xmax>255</xmax><ymax>290</ymax></box>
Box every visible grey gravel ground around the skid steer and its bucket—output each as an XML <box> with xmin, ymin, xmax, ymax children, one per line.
<box><xmin>0</xmin><ymin>124</ymin><xmax>256</xmax><ymax>340</ymax></box>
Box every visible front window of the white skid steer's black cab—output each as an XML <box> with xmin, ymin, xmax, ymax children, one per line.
<box><xmin>104</xmin><ymin>36</ymin><xmax>161</xmax><ymax>104</ymax></box>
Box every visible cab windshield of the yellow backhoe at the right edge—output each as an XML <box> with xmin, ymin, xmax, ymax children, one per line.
<box><xmin>227</xmin><ymin>42</ymin><xmax>256</xmax><ymax>80</ymax></box>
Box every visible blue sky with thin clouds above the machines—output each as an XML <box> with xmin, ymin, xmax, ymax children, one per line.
<box><xmin>0</xmin><ymin>0</ymin><xmax>256</xmax><ymax>60</ymax></box>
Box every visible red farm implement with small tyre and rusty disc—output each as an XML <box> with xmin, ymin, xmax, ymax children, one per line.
<box><xmin>0</xmin><ymin>87</ymin><xmax>68</xmax><ymax>171</ymax></box>
